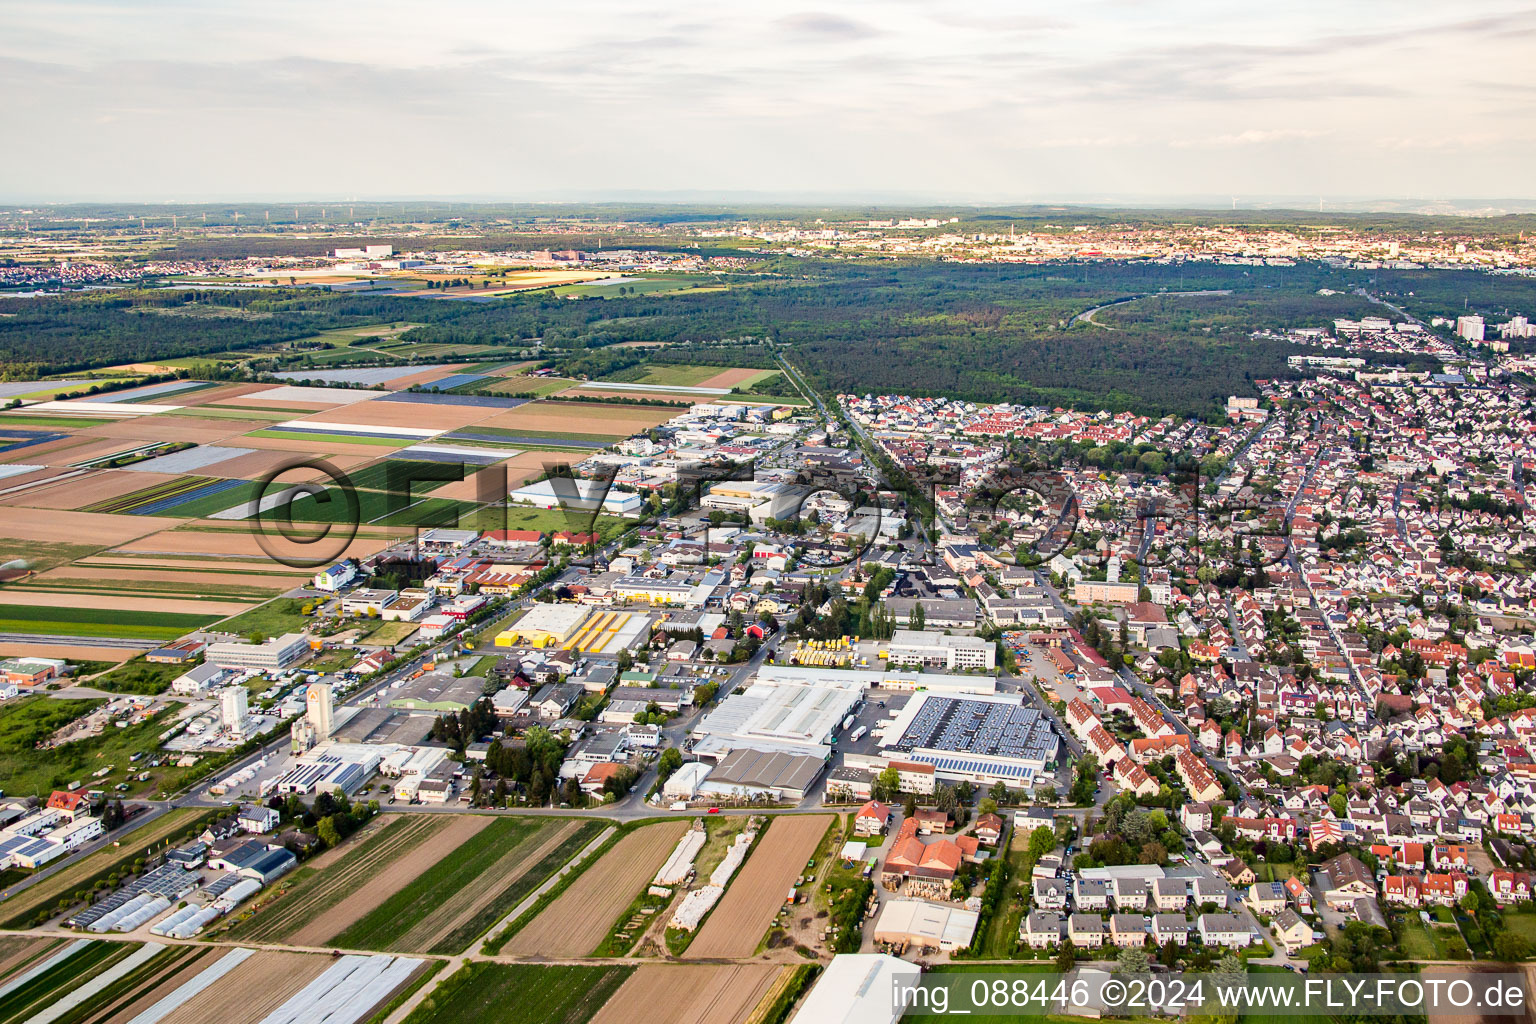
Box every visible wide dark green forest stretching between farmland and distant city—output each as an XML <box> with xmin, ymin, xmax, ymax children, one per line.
<box><xmin>12</xmin><ymin>259</ymin><xmax>1536</xmax><ymax>416</ymax></box>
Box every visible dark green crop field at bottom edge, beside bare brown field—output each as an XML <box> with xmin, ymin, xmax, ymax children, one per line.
<box><xmin>406</xmin><ymin>961</ymin><xmax>634</xmax><ymax>1024</ymax></box>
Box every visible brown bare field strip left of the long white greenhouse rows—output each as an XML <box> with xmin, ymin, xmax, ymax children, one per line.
<box><xmin>501</xmin><ymin>820</ymin><xmax>688</xmax><ymax>956</ymax></box>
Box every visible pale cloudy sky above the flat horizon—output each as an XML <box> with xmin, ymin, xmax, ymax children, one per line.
<box><xmin>0</xmin><ymin>0</ymin><xmax>1536</xmax><ymax>203</ymax></box>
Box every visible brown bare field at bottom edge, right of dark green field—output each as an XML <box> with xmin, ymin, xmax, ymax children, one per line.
<box><xmin>591</xmin><ymin>964</ymin><xmax>786</xmax><ymax>1024</ymax></box>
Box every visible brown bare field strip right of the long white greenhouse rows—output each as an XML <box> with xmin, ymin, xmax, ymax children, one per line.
<box><xmin>688</xmin><ymin>814</ymin><xmax>834</xmax><ymax>958</ymax></box>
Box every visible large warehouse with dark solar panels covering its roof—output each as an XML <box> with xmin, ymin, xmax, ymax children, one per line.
<box><xmin>880</xmin><ymin>692</ymin><xmax>1061</xmax><ymax>788</ymax></box>
